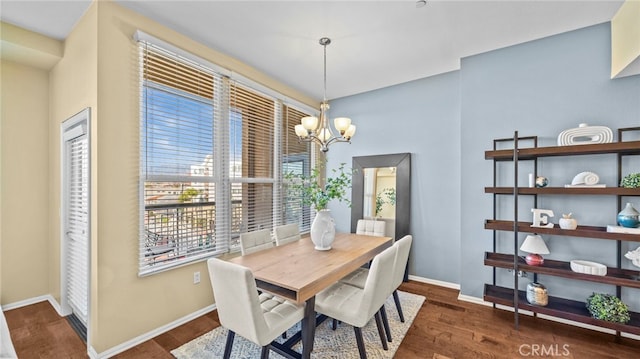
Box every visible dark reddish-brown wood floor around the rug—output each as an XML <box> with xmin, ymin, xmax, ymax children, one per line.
<box><xmin>5</xmin><ymin>281</ymin><xmax>640</xmax><ymax>359</ymax></box>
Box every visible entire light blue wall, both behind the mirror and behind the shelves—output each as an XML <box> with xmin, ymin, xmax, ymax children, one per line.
<box><xmin>328</xmin><ymin>23</ymin><xmax>640</xmax><ymax>304</ymax></box>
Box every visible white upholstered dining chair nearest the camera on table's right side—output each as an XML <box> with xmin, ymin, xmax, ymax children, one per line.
<box><xmin>315</xmin><ymin>246</ymin><xmax>397</xmax><ymax>359</ymax></box>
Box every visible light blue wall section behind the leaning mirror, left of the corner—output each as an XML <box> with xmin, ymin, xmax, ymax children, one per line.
<box><xmin>328</xmin><ymin>71</ymin><xmax>460</xmax><ymax>283</ymax></box>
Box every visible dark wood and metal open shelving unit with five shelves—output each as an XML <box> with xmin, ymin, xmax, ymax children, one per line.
<box><xmin>484</xmin><ymin>127</ymin><xmax>640</xmax><ymax>335</ymax></box>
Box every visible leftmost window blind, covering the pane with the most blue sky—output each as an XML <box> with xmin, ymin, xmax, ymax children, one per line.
<box><xmin>139</xmin><ymin>43</ymin><xmax>228</xmax><ymax>274</ymax></box>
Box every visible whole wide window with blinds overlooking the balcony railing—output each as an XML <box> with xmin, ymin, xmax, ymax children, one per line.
<box><xmin>139</xmin><ymin>37</ymin><xmax>320</xmax><ymax>275</ymax></box>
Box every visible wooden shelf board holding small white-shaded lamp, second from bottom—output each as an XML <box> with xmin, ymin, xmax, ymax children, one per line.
<box><xmin>484</xmin><ymin>252</ymin><xmax>640</xmax><ymax>288</ymax></box>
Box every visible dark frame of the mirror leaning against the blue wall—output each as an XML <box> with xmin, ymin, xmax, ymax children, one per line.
<box><xmin>351</xmin><ymin>152</ymin><xmax>411</xmax><ymax>240</ymax></box>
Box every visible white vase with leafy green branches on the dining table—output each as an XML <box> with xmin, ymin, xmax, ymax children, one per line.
<box><xmin>285</xmin><ymin>163</ymin><xmax>352</xmax><ymax>250</ymax></box>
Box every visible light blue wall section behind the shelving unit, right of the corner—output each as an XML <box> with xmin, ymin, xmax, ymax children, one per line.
<box><xmin>460</xmin><ymin>23</ymin><xmax>640</xmax><ymax>304</ymax></box>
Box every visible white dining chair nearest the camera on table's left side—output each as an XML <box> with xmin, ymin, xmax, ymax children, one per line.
<box><xmin>207</xmin><ymin>258</ymin><xmax>304</xmax><ymax>359</ymax></box>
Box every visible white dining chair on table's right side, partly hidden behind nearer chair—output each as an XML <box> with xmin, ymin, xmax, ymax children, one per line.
<box><xmin>340</xmin><ymin>234</ymin><xmax>413</xmax><ymax>330</ymax></box>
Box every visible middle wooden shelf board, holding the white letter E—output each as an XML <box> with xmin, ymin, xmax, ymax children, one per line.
<box><xmin>484</xmin><ymin>219</ymin><xmax>640</xmax><ymax>242</ymax></box>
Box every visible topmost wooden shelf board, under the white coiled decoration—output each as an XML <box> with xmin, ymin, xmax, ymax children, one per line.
<box><xmin>484</xmin><ymin>141</ymin><xmax>640</xmax><ymax>161</ymax></box>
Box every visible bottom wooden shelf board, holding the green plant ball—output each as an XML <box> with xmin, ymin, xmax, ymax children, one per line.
<box><xmin>484</xmin><ymin>284</ymin><xmax>640</xmax><ymax>335</ymax></box>
